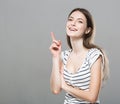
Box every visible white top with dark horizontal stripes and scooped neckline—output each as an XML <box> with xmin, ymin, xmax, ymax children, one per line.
<box><xmin>62</xmin><ymin>48</ymin><xmax>103</xmax><ymax>104</ymax></box>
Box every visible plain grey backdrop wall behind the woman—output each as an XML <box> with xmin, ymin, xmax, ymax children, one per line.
<box><xmin>0</xmin><ymin>0</ymin><xmax>120</xmax><ymax>104</ymax></box>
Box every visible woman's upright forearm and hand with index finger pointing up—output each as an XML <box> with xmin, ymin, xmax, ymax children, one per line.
<box><xmin>49</xmin><ymin>32</ymin><xmax>62</xmax><ymax>94</ymax></box>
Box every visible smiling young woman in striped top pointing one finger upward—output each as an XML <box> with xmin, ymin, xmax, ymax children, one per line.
<box><xmin>50</xmin><ymin>8</ymin><xmax>108</xmax><ymax>104</ymax></box>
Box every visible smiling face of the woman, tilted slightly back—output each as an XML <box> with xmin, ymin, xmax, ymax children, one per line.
<box><xmin>66</xmin><ymin>11</ymin><xmax>87</xmax><ymax>38</ymax></box>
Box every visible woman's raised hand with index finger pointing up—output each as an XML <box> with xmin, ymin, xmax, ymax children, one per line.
<box><xmin>49</xmin><ymin>32</ymin><xmax>61</xmax><ymax>56</ymax></box>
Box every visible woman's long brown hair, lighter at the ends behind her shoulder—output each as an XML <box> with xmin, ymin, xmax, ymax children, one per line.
<box><xmin>67</xmin><ymin>8</ymin><xmax>109</xmax><ymax>80</ymax></box>
